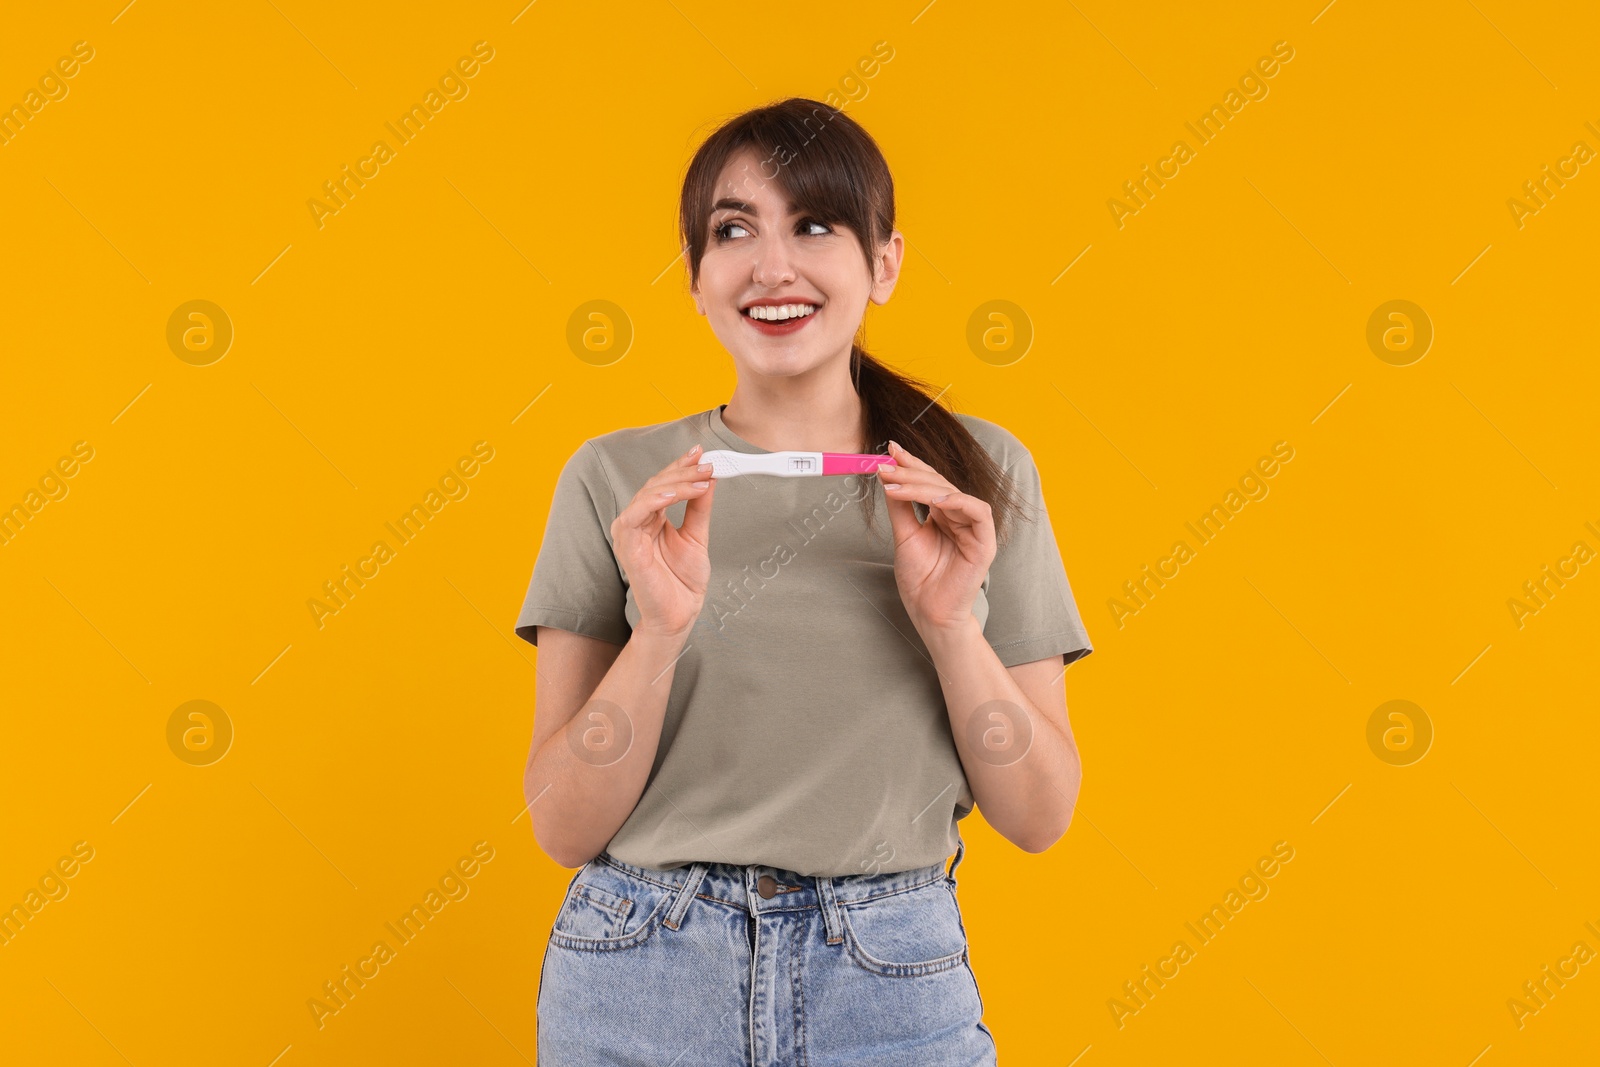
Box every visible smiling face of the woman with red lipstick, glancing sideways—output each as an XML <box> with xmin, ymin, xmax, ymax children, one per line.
<box><xmin>693</xmin><ymin>149</ymin><xmax>904</xmax><ymax>378</ymax></box>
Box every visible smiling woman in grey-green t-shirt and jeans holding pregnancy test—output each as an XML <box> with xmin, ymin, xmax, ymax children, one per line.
<box><xmin>517</xmin><ymin>99</ymin><xmax>1091</xmax><ymax>1067</ymax></box>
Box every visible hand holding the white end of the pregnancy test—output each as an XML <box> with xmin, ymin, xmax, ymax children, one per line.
<box><xmin>611</xmin><ymin>445</ymin><xmax>717</xmax><ymax>633</ymax></box>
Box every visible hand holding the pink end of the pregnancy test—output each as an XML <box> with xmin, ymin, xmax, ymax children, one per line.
<box><xmin>878</xmin><ymin>442</ymin><xmax>995</xmax><ymax>635</ymax></box>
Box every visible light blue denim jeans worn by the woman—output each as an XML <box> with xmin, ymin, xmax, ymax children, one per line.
<box><xmin>536</xmin><ymin>843</ymin><xmax>997</xmax><ymax>1067</ymax></box>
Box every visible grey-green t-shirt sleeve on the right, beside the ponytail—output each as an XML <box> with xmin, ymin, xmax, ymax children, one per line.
<box><xmin>984</xmin><ymin>450</ymin><xmax>1094</xmax><ymax>667</ymax></box>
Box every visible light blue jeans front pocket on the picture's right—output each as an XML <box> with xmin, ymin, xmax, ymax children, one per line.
<box><xmin>838</xmin><ymin>880</ymin><xmax>966</xmax><ymax>977</ymax></box>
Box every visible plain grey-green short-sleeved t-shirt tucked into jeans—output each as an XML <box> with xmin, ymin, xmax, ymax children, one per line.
<box><xmin>515</xmin><ymin>399</ymin><xmax>1093</xmax><ymax>877</ymax></box>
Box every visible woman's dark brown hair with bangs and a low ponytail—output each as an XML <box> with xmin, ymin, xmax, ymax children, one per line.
<box><xmin>678</xmin><ymin>96</ymin><xmax>1026</xmax><ymax>541</ymax></box>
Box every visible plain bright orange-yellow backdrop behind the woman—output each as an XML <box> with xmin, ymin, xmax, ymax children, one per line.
<box><xmin>0</xmin><ymin>0</ymin><xmax>1600</xmax><ymax>1067</ymax></box>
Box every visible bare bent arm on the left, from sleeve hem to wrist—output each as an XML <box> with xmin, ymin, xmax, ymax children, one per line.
<box><xmin>523</xmin><ymin>625</ymin><xmax>688</xmax><ymax>867</ymax></box>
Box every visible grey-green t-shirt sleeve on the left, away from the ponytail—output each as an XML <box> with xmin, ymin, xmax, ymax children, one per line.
<box><xmin>515</xmin><ymin>442</ymin><xmax>632</xmax><ymax>645</ymax></box>
